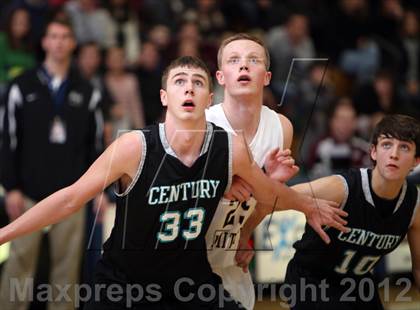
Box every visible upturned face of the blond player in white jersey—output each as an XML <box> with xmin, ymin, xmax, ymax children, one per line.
<box><xmin>216</xmin><ymin>40</ymin><xmax>271</xmax><ymax>96</ymax></box>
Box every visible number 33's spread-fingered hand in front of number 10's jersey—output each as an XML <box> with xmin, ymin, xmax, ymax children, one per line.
<box><xmin>305</xmin><ymin>199</ymin><xmax>350</xmax><ymax>244</ymax></box>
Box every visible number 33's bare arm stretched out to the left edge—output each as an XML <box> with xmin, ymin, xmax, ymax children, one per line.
<box><xmin>0</xmin><ymin>132</ymin><xmax>142</xmax><ymax>244</ymax></box>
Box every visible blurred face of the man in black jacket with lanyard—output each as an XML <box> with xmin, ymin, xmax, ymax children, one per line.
<box><xmin>42</xmin><ymin>23</ymin><xmax>76</xmax><ymax>61</ymax></box>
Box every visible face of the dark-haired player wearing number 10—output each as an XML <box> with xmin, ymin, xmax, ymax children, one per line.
<box><xmin>371</xmin><ymin>136</ymin><xmax>420</xmax><ymax>181</ymax></box>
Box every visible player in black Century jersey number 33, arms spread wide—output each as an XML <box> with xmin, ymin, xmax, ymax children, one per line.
<box><xmin>0</xmin><ymin>57</ymin><xmax>345</xmax><ymax>310</ymax></box>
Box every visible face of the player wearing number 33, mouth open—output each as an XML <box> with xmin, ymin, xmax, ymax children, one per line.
<box><xmin>160</xmin><ymin>67</ymin><xmax>213</xmax><ymax>120</ymax></box>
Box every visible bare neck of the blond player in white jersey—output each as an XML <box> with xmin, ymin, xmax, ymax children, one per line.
<box><xmin>222</xmin><ymin>94</ymin><xmax>262</xmax><ymax>143</ymax></box>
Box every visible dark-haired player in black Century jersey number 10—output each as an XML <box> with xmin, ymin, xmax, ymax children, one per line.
<box><xmin>237</xmin><ymin>115</ymin><xmax>420</xmax><ymax>310</ymax></box>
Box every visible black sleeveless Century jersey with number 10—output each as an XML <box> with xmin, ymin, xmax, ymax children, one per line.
<box><xmin>294</xmin><ymin>169</ymin><xmax>419</xmax><ymax>280</ymax></box>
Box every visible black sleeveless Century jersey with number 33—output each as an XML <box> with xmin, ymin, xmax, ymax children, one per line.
<box><xmin>99</xmin><ymin>123</ymin><xmax>232</xmax><ymax>289</ymax></box>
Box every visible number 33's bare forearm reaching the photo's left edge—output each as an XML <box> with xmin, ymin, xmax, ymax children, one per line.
<box><xmin>0</xmin><ymin>187</ymin><xmax>82</xmax><ymax>244</ymax></box>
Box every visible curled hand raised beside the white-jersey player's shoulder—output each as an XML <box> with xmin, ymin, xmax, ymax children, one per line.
<box><xmin>264</xmin><ymin>148</ymin><xmax>299</xmax><ymax>183</ymax></box>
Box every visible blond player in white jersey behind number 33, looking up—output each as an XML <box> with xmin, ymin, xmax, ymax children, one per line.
<box><xmin>206</xmin><ymin>33</ymin><xmax>347</xmax><ymax>309</ymax></box>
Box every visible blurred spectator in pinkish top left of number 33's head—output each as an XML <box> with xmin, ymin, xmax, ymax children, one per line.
<box><xmin>105</xmin><ymin>47</ymin><xmax>145</xmax><ymax>139</ymax></box>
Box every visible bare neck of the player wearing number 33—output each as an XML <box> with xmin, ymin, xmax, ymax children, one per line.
<box><xmin>164</xmin><ymin>118</ymin><xmax>207</xmax><ymax>166</ymax></box>
